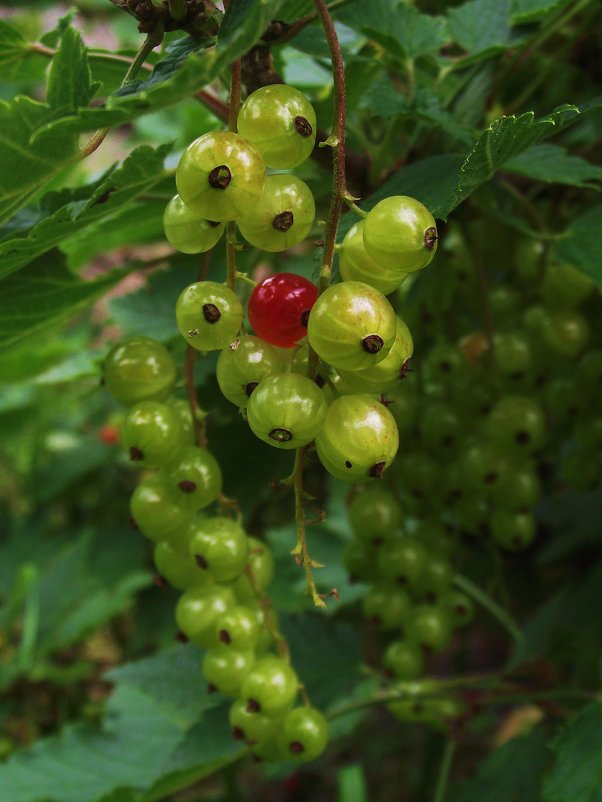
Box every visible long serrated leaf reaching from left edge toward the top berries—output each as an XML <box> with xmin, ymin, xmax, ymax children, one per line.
<box><xmin>0</xmin><ymin>145</ymin><xmax>169</xmax><ymax>277</ymax></box>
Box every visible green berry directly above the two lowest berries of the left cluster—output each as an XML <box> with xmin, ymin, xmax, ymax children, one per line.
<box><xmin>240</xmin><ymin>656</ymin><xmax>299</xmax><ymax>715</ymax></box>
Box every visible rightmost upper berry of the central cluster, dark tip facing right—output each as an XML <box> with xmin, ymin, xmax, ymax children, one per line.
<box><xmin>364</xmin><ymin>195</ymin><xmax>438</xmax><ymax>273</ymax></box>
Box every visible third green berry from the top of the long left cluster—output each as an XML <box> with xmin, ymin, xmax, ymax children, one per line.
<box><xmin>161</xmin><ymin>446</ymin><xmax>222</xmax><ymax>510</ymax></box>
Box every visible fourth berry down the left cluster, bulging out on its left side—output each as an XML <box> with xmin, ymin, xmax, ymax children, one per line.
<box><xmin>130</xmin><ymin>476</ymin><xmax>192</xmax><ymax>541</ymax></box>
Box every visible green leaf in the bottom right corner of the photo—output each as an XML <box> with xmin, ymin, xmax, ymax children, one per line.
<box><xmin>543</xmin><ymin>702</ymin><xmax>602</xmax><ymax>802</ymax></box>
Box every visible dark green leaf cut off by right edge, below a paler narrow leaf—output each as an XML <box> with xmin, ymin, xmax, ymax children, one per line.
<box><xmin>553</xmin><ymin>204</ymin><xmax>602</xmax><ymax>290</ymax></box>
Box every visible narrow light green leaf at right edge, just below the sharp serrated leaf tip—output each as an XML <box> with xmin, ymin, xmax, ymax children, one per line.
<box><xmin>504</xmin><ymin>145</ymin><xmax>602</xmax><ymax>187</ymax></box>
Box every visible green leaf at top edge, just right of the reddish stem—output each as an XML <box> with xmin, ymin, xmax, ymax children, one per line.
<box><xmin>337</xmin><ymin>0</ymin><xmax>448</xmax><ymax>60</ymax></box>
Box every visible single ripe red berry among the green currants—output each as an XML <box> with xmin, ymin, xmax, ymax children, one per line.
<box><xmin>248</xmin><ymin>273</ymin><xmax>318</xmax><ymax>348</ymax></box>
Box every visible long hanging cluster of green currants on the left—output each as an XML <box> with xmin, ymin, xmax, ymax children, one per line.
<box><xmin>103</xmin><ymin>337</ymin><xmax>328</xmax><ymax>761</ymax></box>
